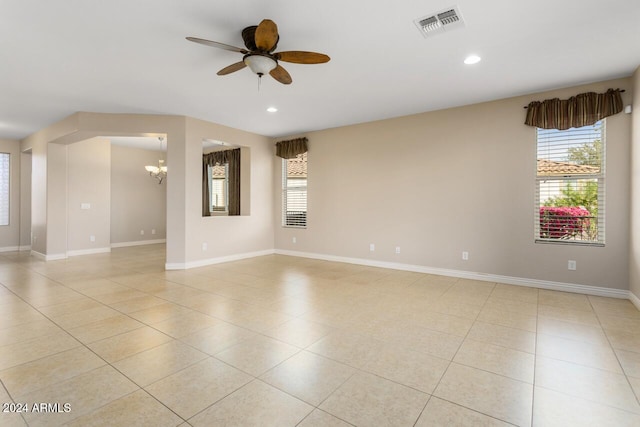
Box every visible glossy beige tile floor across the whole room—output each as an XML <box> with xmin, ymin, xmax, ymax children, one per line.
<box><xmin>0</xmin><ymin>245</ymin><xmax>640</xmax><ymax>427</ymax></box>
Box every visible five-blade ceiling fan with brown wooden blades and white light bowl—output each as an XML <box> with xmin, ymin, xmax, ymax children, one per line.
<box><xmin>187</xmin><ymin>19</ymin><xmax>331</xmax><ymax>85</ymax></box>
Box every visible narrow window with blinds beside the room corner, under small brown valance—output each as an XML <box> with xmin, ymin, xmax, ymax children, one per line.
<box><xmin>282</xmin><ymin>153</ymin><xmax>307</xmax><ymax>228</ymax></box>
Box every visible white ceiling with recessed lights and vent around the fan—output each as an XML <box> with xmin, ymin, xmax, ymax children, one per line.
<box><xmin>0</xmin><ymin>0</ymin><xmax>640</xmax><ymax>139</ymax></box>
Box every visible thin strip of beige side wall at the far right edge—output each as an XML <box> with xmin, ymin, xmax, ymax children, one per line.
<box><xmin>629</xmin><ymin>67</ymin><xmax>640</xmax><ymax>300</ymax></box>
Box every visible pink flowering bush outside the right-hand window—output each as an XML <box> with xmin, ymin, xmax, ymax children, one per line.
<box><xmin>540</xmin><ymin>206</ymin><xmax>591</xmax><ymax>239</ymax></box>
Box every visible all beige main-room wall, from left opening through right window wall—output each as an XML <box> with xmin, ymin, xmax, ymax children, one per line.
<box><xmin>10</xmin><ymin>77</ymin><xmax>640</xmax><ymax>294</ymax></box>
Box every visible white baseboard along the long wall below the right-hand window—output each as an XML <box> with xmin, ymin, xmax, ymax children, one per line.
<box><xmin>275</xmin><ymin>249</ymin><xmax>640</xmax><ymax>304</ymax></box>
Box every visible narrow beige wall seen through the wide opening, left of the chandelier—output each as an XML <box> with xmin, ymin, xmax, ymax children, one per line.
<box><xmin>67</xmin><ymin>138</ymin><xmax>111</xmax><ymax>255</ymax></box>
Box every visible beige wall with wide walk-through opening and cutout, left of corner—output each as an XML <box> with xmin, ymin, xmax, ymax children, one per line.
<box><xmin>15</xmin><ymin>113</ymin><xmax>274</xmax><ymax>268</ymax></box>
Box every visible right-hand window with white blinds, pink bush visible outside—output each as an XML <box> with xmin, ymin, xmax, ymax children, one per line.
<box><xmin>535</xmin><ymin>120</ymin><xmax>606</xmax><ymax>245</ymax></box>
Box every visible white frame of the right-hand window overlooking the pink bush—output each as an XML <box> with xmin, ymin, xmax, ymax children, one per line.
<box><xmin>534</xmin><ymin>119</ymin><xmax>607</xmax><ymax>247</ymax></box>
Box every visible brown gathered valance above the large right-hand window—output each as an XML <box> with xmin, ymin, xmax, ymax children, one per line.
<box><xmin>524</xmin><ymin>89</ymin><xmax>623</xmax><ymax>130</ymax></box>
